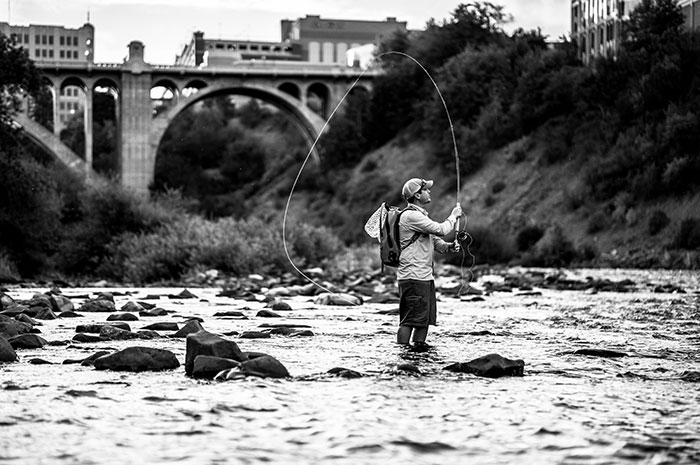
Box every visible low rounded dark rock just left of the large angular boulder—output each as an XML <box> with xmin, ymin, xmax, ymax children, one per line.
<box><xmin>95</xmin><ymin>346</ymin><xmax>180</xmax><ymax>372</ymax></box>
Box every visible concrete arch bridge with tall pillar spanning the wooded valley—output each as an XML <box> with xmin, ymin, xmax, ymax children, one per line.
<box><xmin>26</xmin><ymin>41</ymin><xmax>379</xmax><ymax>195</ymax></box>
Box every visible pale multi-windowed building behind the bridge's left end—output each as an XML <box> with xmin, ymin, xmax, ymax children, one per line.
<box><xmin>0</xmin><ymin>22</ymin><xmax>95</xmax><ymax>131</ymax></box>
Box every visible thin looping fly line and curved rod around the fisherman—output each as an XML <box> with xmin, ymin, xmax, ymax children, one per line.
<box><xmin>282</xmin><ymin>51</ymin><xmax>476</xmax><ymax>303</ymax></box>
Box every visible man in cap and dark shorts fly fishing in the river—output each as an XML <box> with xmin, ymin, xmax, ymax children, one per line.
<box><xmin>396</xmin><ymin>178</ymin><xmax>462</xmax><ymax>348</ymax></box>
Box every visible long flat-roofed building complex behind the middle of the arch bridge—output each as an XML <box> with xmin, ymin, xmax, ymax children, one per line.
<box><xmin>175</xmin><ymin>15</ymin><xmax>406</xmax><ymax>66</ymax></box>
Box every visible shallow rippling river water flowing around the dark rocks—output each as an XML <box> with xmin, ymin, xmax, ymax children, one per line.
<box><xmin>0</xmin><ymin>270</ymin><xmax>700</xmax><ymax>465</ymax></box>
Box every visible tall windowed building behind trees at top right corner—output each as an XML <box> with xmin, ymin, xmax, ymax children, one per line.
<box><xmin>571</xmin><ymin>0</ymin><xmax>700</xmax><ymax>64</ymax></box>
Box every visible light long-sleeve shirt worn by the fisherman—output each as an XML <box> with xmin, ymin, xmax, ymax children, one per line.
<box><xmin>396</xmin><ymin>204</ymin><xmax>455</xmax><ymax>281</ymax></box>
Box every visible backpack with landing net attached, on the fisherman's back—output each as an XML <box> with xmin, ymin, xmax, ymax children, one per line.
<box><xmin>365</xmin><ymin>202</ymin><xmax>420</xmax><ymax>268</ymax></box>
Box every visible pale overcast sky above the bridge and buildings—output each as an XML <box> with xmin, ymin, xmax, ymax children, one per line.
<box><xmin>0</xmin><ymin>0</ymin><xmax>571</xmax><ymax>64</ymax></box>
